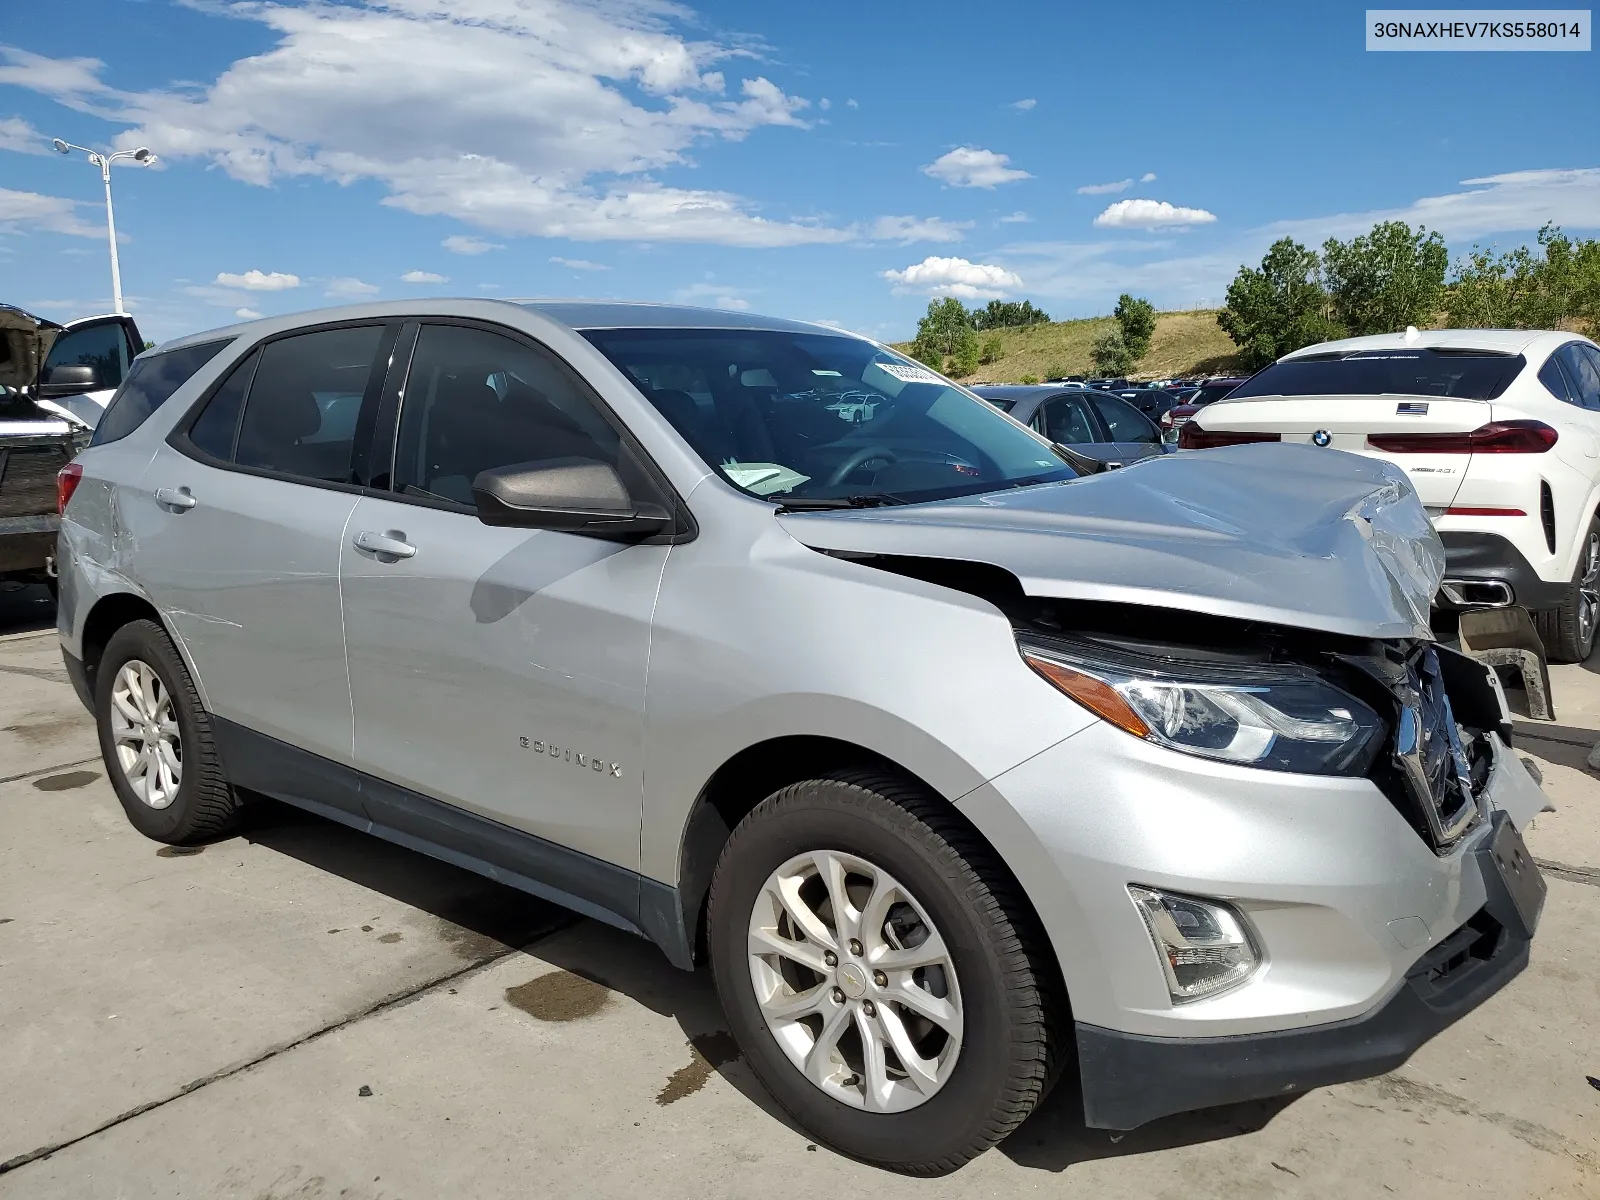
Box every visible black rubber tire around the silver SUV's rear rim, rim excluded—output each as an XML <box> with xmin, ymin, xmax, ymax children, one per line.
<box><xmin>94</xmin><ymin>621</ymin><xmax>240</xmax><ymax>845</ymax></box>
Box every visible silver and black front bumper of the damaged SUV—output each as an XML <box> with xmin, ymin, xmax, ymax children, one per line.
<box><xmin>958</xmin><ymin>704</ymin><xmax>1544</xmax><ymax>1128</ymax></box>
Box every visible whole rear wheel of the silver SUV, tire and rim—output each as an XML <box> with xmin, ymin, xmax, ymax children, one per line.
<box><xmin>94</xmin><ymin>621</ymin><xmax>238</xmax><ymax>843</ymax></box>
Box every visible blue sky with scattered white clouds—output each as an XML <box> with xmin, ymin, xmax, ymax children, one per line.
<box><xmin>0</xmin><ymin>0</ymin><xmax>1600</xmax><ymax>339</ymax></box>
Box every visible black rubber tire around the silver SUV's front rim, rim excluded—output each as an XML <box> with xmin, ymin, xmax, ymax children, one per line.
<box><xmin>707</xmin><ymin>773</ymin><xmax>1061</xmax><ymax>1176</ymax></box>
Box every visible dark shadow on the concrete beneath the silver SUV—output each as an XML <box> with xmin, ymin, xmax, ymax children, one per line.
<box><xmin>233</xmin><ymin>802</ymin><xmax>1291</xmax><ymax>1171</ymax></box>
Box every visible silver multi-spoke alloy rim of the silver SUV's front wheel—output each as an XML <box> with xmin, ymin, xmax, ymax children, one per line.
<box><xmin>749</xmin><ymin>850</ymin><xmax>963</xmax><ymax>1112</ymax></box>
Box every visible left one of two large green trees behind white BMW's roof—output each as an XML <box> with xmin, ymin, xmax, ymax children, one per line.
<box><xmin>1216</xmin><ymin>237</ymin><xmax>1344</xmax><ymax>371</ymax></box>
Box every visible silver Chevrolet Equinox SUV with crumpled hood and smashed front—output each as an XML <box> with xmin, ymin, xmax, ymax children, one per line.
<box><xmin>59</xmin><ymin>301</ymin><xmax>1542</xmax><ymax>1173</ymax></box>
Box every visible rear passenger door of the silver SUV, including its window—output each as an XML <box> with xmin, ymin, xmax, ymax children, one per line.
<box><xmin>126</xmin><ymin>325</ymin><xmax>394</xmax><ymax>763</ymax></box>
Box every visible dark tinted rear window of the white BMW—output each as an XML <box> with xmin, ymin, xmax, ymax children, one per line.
<box><xmin>1227</xmin><ymin>349</ymin><xmax>1526</xmax><ymax>400</ymax></box>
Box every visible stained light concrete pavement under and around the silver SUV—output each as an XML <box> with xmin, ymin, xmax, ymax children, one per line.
<box><xmin>0</xmin><ymin>598</ymin><xmax>1600</xmax><ymax>1200</ymax></box>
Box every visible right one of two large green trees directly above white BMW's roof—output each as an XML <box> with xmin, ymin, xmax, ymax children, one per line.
<box><xmin>1322</xmin><ymin>221</ymin><xmax>1450</xmax><ymax>336</ymax></box>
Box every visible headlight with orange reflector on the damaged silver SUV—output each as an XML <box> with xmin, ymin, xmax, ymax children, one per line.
<box><xmin>1021</xmin><ymin>642</ymin><xmax>1384</xmax><ymax>774</ymax></box>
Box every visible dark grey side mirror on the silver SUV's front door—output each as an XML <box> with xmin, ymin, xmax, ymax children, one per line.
<box><xmin>472</xmin><ymin>458</ymin><xmax>672</xmax><ymax>538</ymax></box>
